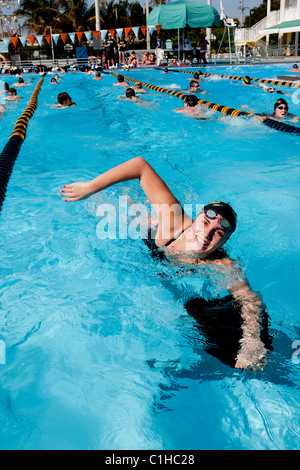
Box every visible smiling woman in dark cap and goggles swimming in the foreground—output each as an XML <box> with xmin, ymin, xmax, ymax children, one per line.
<box><xmin>62</xmin><ymin>157</ymin><xmax>267</xmax><ymax>369</ymax></box>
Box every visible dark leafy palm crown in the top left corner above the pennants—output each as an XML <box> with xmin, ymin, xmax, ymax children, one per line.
<box><xmin>16</xmin><ymin>0</ymin><xmax>61</xmax><ymax>34</ymax></box>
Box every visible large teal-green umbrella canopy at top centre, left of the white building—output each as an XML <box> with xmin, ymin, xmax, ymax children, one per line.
<box><xmin>147</xmin><ymin>0</ymin><xmax>220</xmax><ymax>29</ymax></box>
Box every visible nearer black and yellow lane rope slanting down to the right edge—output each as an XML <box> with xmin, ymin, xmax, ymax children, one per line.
<box><xmin>111</xmin><ymin>73</ymin><xmax>300</xmax><ymax>135</ymax></box>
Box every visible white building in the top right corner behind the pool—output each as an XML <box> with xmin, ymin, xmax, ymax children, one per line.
<box><xmin>235</xmin><ymin>0</ymin><xmax>300</xmax><ymax>54</ymax></box>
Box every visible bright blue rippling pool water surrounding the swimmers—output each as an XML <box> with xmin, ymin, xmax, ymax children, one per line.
<box><xmin>0</xmin><ymin>65</ymin><xmax>300</xmax><ymax>450</ymax></box>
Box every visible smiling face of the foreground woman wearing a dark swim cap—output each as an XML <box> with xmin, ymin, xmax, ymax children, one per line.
<box><xmin>189</xmin><ymin>211</ymin><xmax>231</xmax><ymax>255</ymax></box>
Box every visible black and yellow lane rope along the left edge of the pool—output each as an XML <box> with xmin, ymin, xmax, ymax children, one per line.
<box><xmin>0</xmin><ymin>74</ymin><xmax>45</xmax><ymax>212</ymax></box>
